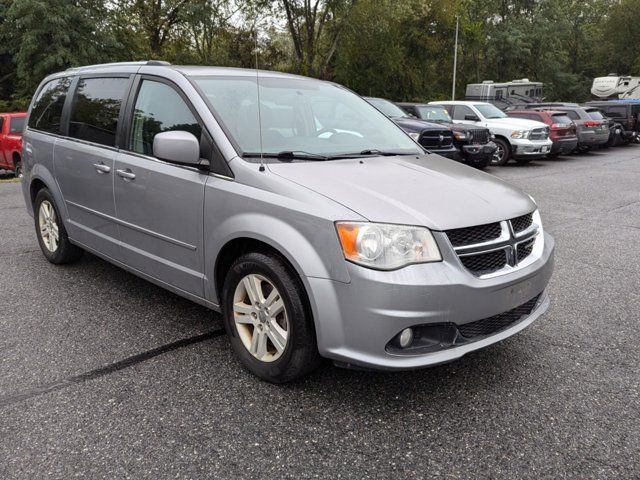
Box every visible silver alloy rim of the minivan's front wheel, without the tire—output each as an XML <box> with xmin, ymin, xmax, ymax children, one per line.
<box><xmin>233</xmin><ymin>274</ymin><xmax>289</xmax><ymax>362</ymax></box>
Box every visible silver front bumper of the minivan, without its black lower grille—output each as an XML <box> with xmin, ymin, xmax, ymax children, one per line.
<box><xmin>307</xmin><ymin>232</ymin><xmax>554</xmax><ymax>370</ymax></box>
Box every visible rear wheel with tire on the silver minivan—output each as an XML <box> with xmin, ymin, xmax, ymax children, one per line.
<box><xmin>33</xmin><ymin>188</ymin><xmax>82</xmax><ymax>264</ymax></box>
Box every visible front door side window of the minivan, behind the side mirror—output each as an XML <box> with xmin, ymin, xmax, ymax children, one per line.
<box><xmin>129</xmin><ymin>80</ymin><xmax>202</xmax><ymax>156</ymax></box>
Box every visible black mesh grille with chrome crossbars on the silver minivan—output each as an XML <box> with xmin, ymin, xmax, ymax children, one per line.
<box><xmin>444</xmin><ymin>213</ymin><xmax>542</xmax><ymax>277</ymax></box>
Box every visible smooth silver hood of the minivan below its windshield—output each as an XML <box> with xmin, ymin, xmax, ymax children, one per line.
<box><xmin>268</xmin><ymin>154</ymin><xmax>536</xmax><ymax>230</ymax></box>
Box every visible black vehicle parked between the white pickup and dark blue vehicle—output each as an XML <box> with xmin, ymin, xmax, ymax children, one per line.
<box><xmin>397</xmin><ymin>102</ymin><xmax>498</xmax><ymax>169</ymax></box>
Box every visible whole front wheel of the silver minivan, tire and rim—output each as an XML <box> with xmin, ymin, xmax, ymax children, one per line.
<box><xmin>222</xmin><ymin>252</ymin><xmax>321</xmax><ymax>383</ymax></box>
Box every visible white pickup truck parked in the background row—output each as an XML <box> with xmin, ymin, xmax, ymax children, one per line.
<box><xmin>429</xmin><ymin>101</ymin><xmax>553</xmax><ymax>165</ymax></box>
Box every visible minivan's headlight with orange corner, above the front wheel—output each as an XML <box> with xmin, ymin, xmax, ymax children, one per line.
<box><xmin>336</xmin><ymin>222</ymin><xmax>442</xmax><ymax>270</ymax></box>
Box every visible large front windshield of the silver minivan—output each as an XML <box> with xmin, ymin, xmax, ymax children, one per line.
<box><xmin>194</xmin><ymin>76</ymin><xmax>424</xmax><ymax>156</ymax></box>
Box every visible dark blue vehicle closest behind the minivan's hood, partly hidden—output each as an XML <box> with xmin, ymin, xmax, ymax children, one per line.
<box><xmin>365</xmin><ymin>97</ymin><xmax>458</xmax><ymax>160</ymax></box>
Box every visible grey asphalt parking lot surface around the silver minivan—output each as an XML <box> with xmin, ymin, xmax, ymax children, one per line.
<box><xmin>0</xmin><ymin>146</ymin><xmax>640</xmax><ymax>479</ymax></box>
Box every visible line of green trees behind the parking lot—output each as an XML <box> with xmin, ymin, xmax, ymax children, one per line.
<box><xmin>0</xmin><ymin>0</ymin><xmax>640</xmax><ymax>110</ymax></box>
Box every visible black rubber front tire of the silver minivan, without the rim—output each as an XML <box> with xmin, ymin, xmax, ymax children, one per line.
<box><xmin>222</xmin><ymin>252</ymin><xmax>322</xmax><ymax>383</ymax></box>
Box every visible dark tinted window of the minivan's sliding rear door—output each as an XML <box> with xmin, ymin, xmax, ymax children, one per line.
<box><xmin>69</xmin><ymin>78</ymin><xmax>129</xmax><ymax>147</ymax></box>
